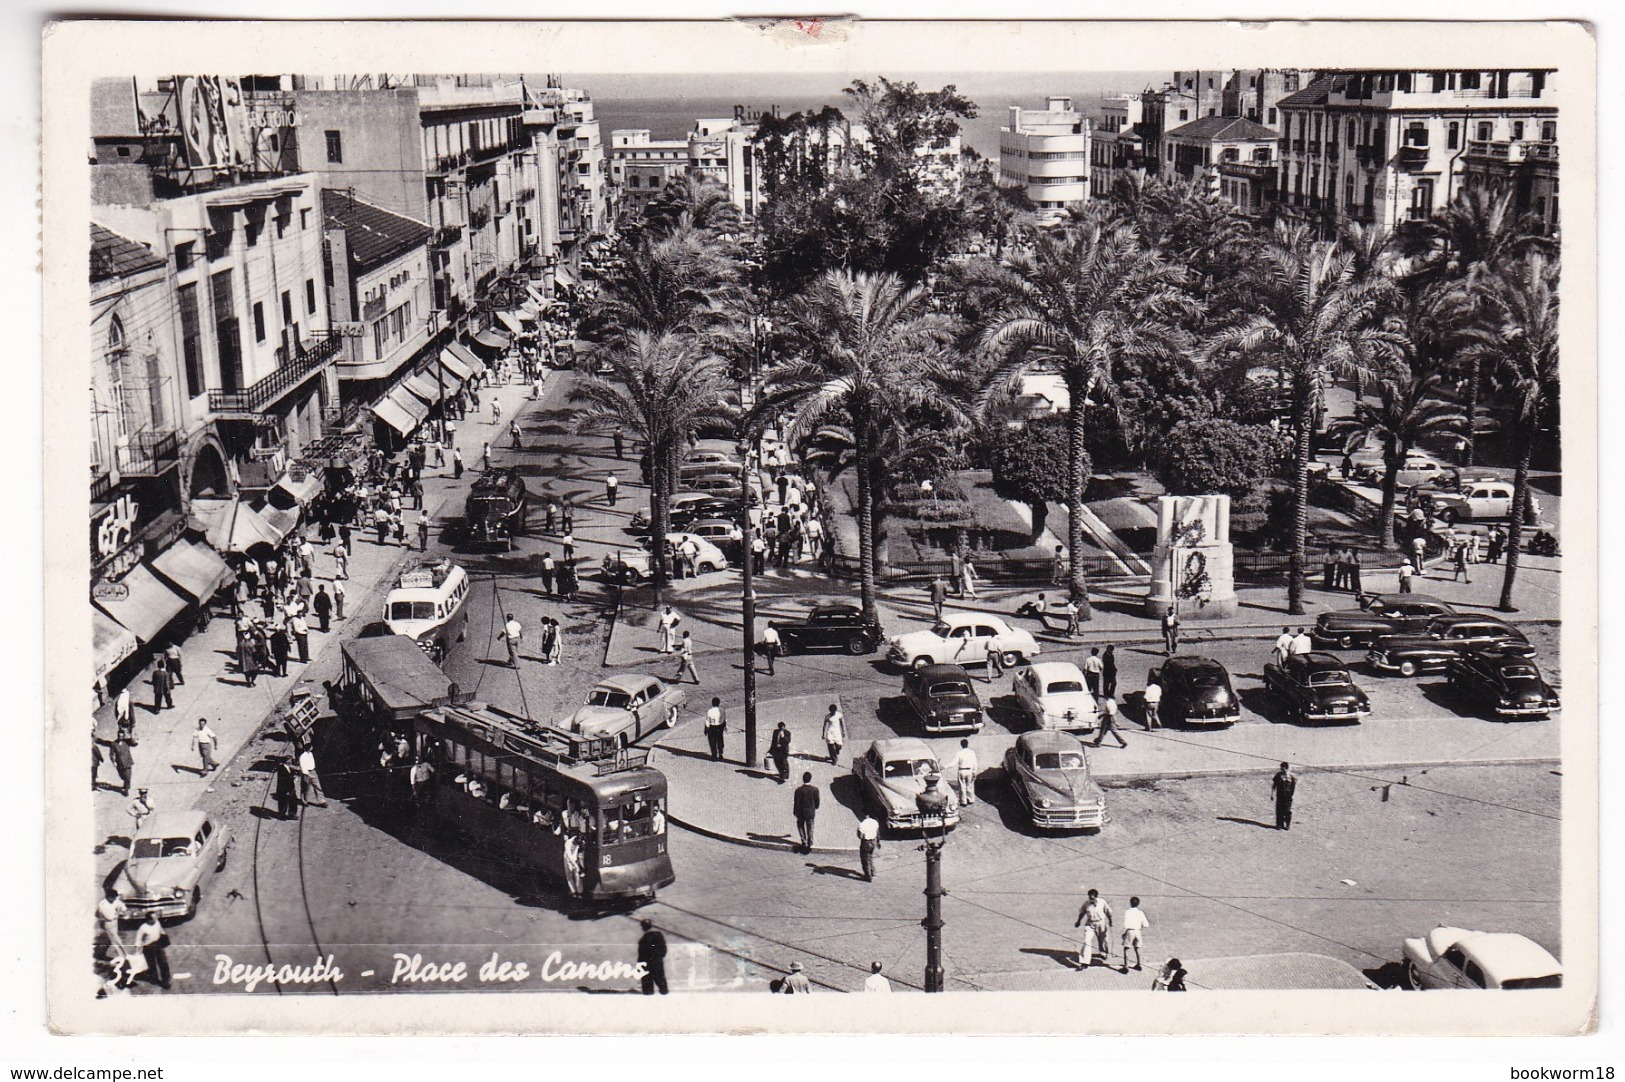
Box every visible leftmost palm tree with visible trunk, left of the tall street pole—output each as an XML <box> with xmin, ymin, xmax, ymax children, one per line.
<box><xmin>569</xmin><ymin>330</ymin><xmax>731</xmax><ymax>603</ymax></box>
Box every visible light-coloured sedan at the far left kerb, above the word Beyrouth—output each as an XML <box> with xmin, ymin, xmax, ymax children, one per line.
<box><xmin>112</xmin><ymin>807</ymin><xmax>231</xmax><ymax>921</ymax></box>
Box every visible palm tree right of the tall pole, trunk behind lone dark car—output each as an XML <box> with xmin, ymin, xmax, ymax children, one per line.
<box><xmin>761</xmin><ymin>270</ymin><xmax>952</xmax><ymax>619</ymax></box>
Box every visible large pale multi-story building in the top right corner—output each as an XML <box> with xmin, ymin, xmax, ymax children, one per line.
<box><xmin>1279</xmin><ymin>70</ymin><xmax>1557</xmax><ymax>229</ymax></box>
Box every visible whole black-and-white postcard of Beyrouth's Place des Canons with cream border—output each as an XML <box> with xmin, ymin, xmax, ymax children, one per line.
<box><xmin>42</xmin><ymin>18</ymin><xmax>1597</xmax><ymax>1035</ymax></box>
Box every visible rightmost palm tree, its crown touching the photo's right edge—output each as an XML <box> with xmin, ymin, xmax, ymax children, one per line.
<box><xmin>1464</xmin><ymin>252</ymin><xmax>1560</xmax><ymax>612</ymax></box>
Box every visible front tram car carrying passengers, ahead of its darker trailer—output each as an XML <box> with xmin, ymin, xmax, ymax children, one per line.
<box><xmin>413</xmin><ymin>703</ymin><xmax>676</xmax><ymax>903</ymax></box>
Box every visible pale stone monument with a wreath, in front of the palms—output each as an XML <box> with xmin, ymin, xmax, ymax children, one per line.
<box><xmin>1146</xmin><ymin>496</ymin><xmax>1237</xmax><ymax>621</ymax></box>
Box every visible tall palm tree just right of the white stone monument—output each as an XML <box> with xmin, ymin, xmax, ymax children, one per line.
<box><xmin>1207</xmin><ymin>229</ymin><xmax>1402</xmax><ymax>616</ymax></box>
